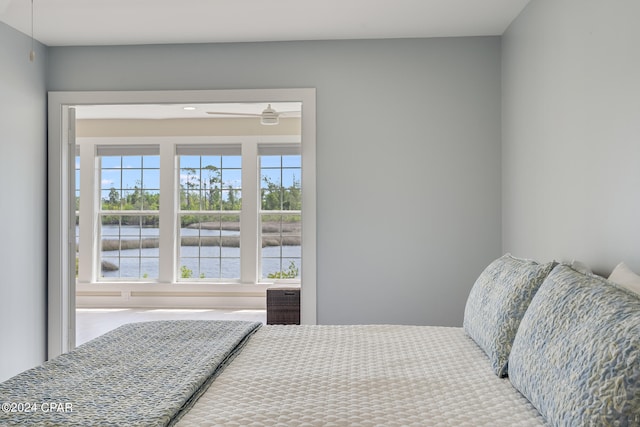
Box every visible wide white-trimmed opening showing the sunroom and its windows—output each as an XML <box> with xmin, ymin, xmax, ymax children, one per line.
<box><xmin>48</xmin><ymin>89</ymin><xmax>316</xmax><ymax>357</ymax></box>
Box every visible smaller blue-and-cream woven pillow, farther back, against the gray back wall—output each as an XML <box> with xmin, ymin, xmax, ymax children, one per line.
<box><xmin>463</xmin><ymin>254</ymin><xmax>555</xmax><ymax>377</ymax></box>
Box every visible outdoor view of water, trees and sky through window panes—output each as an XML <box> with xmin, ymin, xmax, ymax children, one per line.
<box><xmin>76</xmin><ymin>146</ymin><xmax>302</xmax><ymax>282</ymax></box>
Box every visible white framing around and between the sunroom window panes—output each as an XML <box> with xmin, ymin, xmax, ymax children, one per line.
<box><xmin>76</xmin><ymin>135</ymin><xmax>304</xmax><ymax>286</ymax></box>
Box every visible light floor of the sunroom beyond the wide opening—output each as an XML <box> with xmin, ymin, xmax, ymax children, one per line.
<box><xmin>76</xmin><ymin>308</ymin><xmax>267</xmax><ymax>345</ymax></box>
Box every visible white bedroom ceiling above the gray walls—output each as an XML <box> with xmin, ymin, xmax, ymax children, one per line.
<box><xmin>0</xmin><ymin>0</ymin><xmax>529</xmax><ymax>46</ymax></box>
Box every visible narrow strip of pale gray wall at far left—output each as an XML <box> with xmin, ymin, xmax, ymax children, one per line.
<box><xmin>0</xmin><ymin>22</ymin><xmax>47</xmax><ymax>381</ymax></box>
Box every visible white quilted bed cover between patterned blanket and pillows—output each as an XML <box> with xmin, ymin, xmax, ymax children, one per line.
<box><xmin>178</xmin><ymin>325</ymin><xmax>544</xmax><ymax>427</ymax></box>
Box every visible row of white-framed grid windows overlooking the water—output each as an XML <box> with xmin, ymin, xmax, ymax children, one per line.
<box><xmin>76</xmin><ymin>137</ymin><xmax>302</xmax><ymax>284</ymax></box>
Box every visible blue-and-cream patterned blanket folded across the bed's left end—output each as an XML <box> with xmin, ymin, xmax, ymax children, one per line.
<box><xmin>0</xmin><ymin>320</ymin><xmax>261</xmax><ymax>427</ymax></box>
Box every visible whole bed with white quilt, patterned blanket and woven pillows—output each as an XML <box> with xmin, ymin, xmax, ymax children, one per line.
<box><xmin>0</xmin><ymin>255</ymin><xmax>640</xmax><ymax>426</ymax></box>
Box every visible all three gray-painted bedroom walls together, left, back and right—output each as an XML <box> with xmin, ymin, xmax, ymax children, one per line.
<box><xmin>5</xmin><ymin>0</ymin><xmax>640</xmax><ymax>380</ymax></box>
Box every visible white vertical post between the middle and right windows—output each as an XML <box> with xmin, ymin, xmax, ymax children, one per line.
<box><xmin>240</xmin><ymin>141</ymin><xmax>260</xmax><ymax>284</ymax></box>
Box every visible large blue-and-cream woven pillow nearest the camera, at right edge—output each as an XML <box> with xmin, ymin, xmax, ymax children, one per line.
<box><xmin>509</xmin><ymin>265</ymin><xmax>640</xmax><ymax>426</ymax></box>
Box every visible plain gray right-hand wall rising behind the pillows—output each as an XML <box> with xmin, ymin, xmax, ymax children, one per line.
<box><xmin>502</xmin><ymin>0</ymin><xmax>640</xmax><ymax>274</ymax></box>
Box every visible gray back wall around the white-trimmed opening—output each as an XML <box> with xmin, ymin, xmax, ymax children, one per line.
<box><xmin>48</xmin><ymin>37</ymin><xmax>501</xmax><ymax>325</ymax></box>
